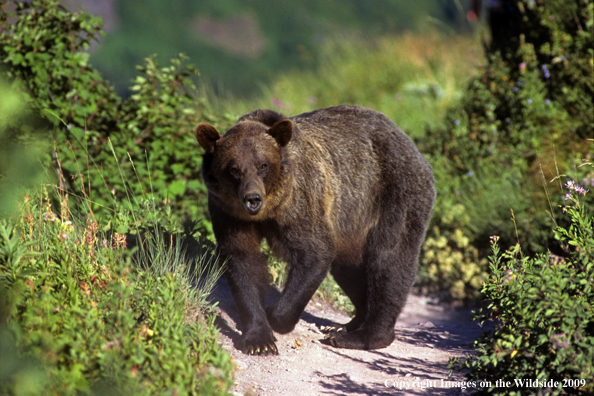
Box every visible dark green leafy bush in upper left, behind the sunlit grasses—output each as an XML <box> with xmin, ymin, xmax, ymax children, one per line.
<box><xmin>0</xmin><ymin>0</ymin><xmax>229</xmax><ymax>226</ymax></box>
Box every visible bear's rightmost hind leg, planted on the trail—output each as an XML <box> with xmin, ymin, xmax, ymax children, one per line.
<box><xmin>330</xmin><ymin>213</ymin><xmax>427</xmax><ymax>350</ymax></box>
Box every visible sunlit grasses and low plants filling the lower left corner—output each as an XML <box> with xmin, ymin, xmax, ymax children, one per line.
<box><xmin>0</xmin><ymin>187</ymin><xmax>232</xmax><ymax>395</ymax></box>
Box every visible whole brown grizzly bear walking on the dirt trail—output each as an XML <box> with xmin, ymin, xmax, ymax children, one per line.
<box><xmin>196</xmin><ymin>106</ymin><xmax>435</xmax><ymax>355</ymax></box>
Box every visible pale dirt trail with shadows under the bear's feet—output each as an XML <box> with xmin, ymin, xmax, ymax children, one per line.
<box><xmin>212</xmin><ymin>280</ymin><xmax>481</xmax><ymax>396</ymax></box>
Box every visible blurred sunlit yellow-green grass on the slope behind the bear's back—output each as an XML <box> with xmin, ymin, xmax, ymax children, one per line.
<box><xmin>227</xmin><ymin>31</ymin><xmax>484</xmax><ymax>141</ymax></box>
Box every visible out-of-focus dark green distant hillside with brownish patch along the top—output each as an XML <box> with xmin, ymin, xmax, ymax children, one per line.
<box><xmin>86</xmin><ymin>0</ymin><xmax>468</xmax><ymax>97</ymax></box>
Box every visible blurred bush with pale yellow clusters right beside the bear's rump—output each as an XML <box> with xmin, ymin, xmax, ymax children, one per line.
<box><xmin>416</xmin><ymin>157</ymin><xmax>553</xmax><ymax>300</ymax></box>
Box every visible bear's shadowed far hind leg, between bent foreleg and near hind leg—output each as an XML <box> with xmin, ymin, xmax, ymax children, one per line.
<box><xmin>330</xmin><ymin>263</ymin><xmax>367</xmax><ymax>332</ymax></box>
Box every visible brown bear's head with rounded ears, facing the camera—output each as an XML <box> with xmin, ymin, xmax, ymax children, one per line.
<box><xmin>196</xmin><ymin>119</ymin><xmax>293</xmax><ymax>219</ymax></box>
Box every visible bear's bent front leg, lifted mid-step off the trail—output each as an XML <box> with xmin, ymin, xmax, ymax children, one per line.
<box><xmin>266</xmin><ymin>248</ymin><xmax>332</xmax><ymax>334</ymax></box>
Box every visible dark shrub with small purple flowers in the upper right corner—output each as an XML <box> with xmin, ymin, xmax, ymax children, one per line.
<box><xmin>426</xmin><ymin>0</ymin><xmax>594</xmax><ymax>174</ymax></box>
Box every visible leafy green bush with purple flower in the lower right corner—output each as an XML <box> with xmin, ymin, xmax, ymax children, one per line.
<box><xmin>466</xmin><ymin>169</ymin><xmax>594</xmax><ymax>395</ymax></box>
